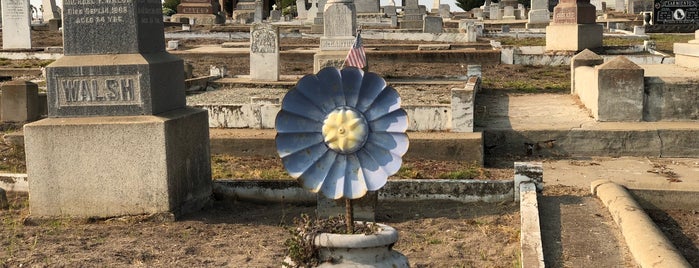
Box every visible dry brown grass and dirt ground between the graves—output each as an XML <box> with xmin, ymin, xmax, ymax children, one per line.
<box><xmin>0</xmin><ymin>29</ymin><xmax>699</xmax><ymax>267</ymax></box>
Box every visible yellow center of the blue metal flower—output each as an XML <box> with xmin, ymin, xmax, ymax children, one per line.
<box><xmin>323</xmin><ymin>107</ymin><xmax>368</xmax><ymax>153</ymax></box>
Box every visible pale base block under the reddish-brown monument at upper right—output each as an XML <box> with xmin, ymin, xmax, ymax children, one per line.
<box><xmin>546</xmin><ymin>24</ymin><xmax>602</xmax><ymax>51</ymax></box>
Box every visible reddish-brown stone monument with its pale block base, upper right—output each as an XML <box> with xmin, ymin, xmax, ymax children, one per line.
<box><xmin>546</xmin><ymin>0</ymin><xmax>602</xmax><ymax>51</ymax></box>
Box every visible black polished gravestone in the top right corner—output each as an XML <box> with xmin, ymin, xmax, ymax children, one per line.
<box><xmin>646</xmin><ymin>0</ymin><xmax>699</xmax><ymax>33</ymax></box>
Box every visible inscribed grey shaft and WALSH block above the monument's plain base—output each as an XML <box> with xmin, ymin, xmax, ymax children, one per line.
<box><xmin>51</xmin><ymin>0</ymin><xmax>185</xmax><ymax>117</ymax></box>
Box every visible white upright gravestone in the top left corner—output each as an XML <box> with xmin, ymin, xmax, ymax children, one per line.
<box><xmin>0</xmin><ymin>0</ymin><xmax>32</xmax><ymax>49</ymax></box>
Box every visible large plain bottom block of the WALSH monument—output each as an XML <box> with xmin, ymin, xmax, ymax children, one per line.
<box><xmin>24</xmin><ymin>108</ymin><xmax>212</xmax><ymax>218</ymax></box>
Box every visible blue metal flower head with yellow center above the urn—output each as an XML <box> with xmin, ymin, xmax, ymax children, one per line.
<box><xmin>275</xmin><ymin>67</ymin><xmax>408</xmax><ymax>199</ymax></box>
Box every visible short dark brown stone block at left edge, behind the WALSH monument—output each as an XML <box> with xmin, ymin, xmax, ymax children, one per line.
<box><xmin>0</xmin><ymin>80</ymin><xmax>39</xmax><ymax>122</ymax></box>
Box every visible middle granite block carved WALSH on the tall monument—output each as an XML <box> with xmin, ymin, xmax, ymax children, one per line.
<box><xmin>46</xmin><ymin>51</ymin><xmax>185</xmax><ymax>117</ymax></box>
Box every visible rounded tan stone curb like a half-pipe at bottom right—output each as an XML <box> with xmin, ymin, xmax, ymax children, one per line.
<box><xmin>591</xmin><ymin>180</ymin><xmax>691</xmax><ymax>268</ymax></box>
